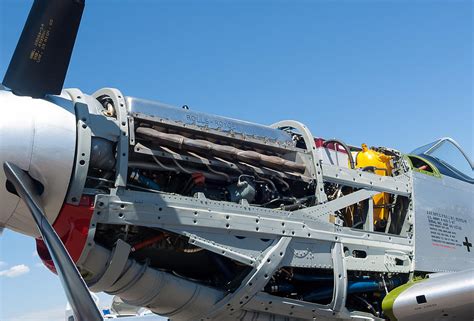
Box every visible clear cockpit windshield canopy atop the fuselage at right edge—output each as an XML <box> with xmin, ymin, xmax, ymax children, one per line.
<box><xmin>411</xmin><ymin>137</ymin><xmax>474</xmax><ymax>184</ymax></box>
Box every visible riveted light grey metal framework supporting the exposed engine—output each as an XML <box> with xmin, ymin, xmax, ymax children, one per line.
<box><xmin>72</xmin><ymin>89</ymin><xmax>414</xmax><ymax>320</ymax></box>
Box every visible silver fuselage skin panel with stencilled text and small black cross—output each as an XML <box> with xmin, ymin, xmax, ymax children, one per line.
<box><xmin>413</xmin><ymin>172</ymin><xmax>474</xmax><ymax>272</ymax></box>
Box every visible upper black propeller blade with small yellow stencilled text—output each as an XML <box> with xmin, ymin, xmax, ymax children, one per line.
<box><xmin>3</xmin><ymin>0</ymin><xmax>85</xmax><ymax>98</ymax></box>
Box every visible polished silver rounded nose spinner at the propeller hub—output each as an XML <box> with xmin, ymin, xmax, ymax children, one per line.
<box><xmin>0</xmin><ymin>90</ymin><xmax>76</xmax><ymax>236</ymax></box>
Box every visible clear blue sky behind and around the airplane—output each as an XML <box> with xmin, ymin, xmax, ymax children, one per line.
<box><xmin>0</xmin><ymin>0</ymin><xmax>474</xmax><ymax>321</ymax></box>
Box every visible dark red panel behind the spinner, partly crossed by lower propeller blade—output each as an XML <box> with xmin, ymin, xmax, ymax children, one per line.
<box><xmin>36</xmin><ymin>196</ymin><xmax>94</xmax><ymax>273</ymax></box>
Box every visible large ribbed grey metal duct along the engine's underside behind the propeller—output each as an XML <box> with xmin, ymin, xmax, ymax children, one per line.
<box><xmin>80</xmin><ymin>239</ymin><xmax>226</xmax><ymax>321</ymax></box>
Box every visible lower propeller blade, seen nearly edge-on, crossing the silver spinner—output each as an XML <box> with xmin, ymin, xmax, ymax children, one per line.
<box><xmin>3</xmin><ymin>162</ymin><xmax>103</xmax><ymax>321</ymax></box>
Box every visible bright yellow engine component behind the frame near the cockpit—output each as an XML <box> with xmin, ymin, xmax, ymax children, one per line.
<box><xmin>356</xmin><ymin>144</ymin><xmax>392</xmax><ymax>226</ymax></box>
